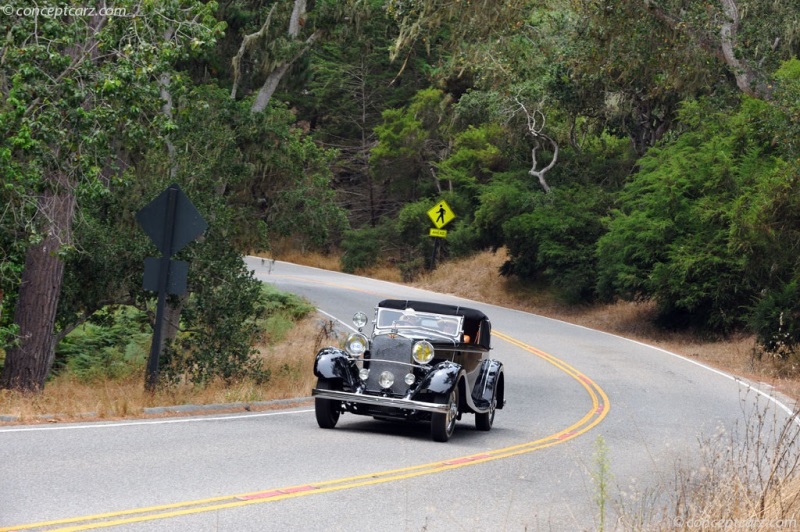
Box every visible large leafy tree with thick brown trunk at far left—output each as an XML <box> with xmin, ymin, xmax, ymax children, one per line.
<box><xmin>0</xmin><ymin>2</ymin><xmax>221</xmax><ymax>391</ymax></box>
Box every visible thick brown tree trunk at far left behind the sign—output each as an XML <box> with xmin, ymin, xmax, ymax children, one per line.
<box><xmin>0</xmin><ymin>179</ymin><xmax>75</xmax><ymax>392</ymax></box>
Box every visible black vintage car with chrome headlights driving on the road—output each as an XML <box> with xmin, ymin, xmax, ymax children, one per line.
<box><xmin>312</xmin><ymin>299</ymin><xmax>505</xmax><ymax>442</ymax></box>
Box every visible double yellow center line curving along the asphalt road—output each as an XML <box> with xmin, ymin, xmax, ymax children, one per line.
<box><xmin>0</xmin><ymin>330</ymin><xmax>610</xmax><ymax>532</ymax></box>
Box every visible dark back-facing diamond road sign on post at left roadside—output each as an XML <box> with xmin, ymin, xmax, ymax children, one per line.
<box><xmin>136</xmin><ymin>184</ymin><xmax>208</xmax><ymax>393</ymax></box>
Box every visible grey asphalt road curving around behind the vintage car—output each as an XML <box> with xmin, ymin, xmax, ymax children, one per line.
<box><xmin>0</xmin><ymin>259</ymin><xmax>796</xmax><ymax>531</ymax></box>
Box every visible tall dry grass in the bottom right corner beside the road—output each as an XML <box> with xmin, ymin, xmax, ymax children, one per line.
<box><xmin>617</xmin><ymin>392</ymin><xmax>800</xmax><ymax>531</ymax></box>
